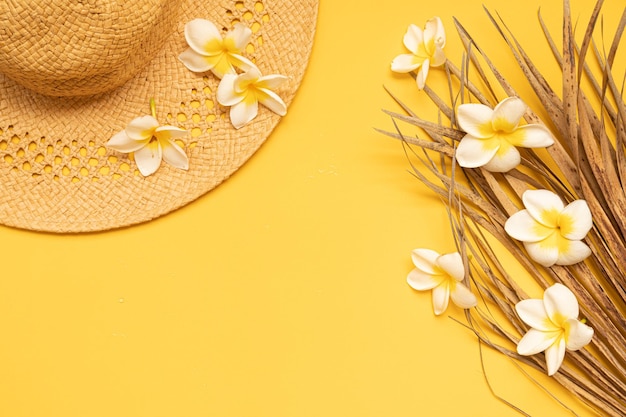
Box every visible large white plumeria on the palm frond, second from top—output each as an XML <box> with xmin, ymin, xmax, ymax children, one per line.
<box><xmin>456</xmin><ymin>97</ymin><xmax>554</xmax><ymax>172</ymax></box>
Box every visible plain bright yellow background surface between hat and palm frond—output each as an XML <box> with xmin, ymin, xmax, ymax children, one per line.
<box><xmin>0</xmin><ymin>0</ymin><xmax>623</xmax><ymax>417</ymax></box>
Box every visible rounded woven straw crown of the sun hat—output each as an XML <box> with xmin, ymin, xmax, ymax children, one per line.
<box><xmin>0</xmin><ymin>0</ymin><xmax>181</xmax><ymax>96</ymax></box>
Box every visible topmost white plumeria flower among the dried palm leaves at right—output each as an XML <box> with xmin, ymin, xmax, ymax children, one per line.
<box><xmin>391</xmin><ymin>17</ymin><xmax>446</xmax><ymax>90</ymax></box>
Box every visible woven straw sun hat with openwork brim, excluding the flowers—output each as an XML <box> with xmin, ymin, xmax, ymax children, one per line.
<box><xmin>0</xmin><ymin>0</ymin><xmax>318</xmax><ymax>232</ymax></box>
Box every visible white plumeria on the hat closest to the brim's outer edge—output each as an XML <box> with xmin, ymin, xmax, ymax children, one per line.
<box><xmin>217</xmin><ymin>66</ymin><xmax>287</xmax><ymax>129</ymax></box>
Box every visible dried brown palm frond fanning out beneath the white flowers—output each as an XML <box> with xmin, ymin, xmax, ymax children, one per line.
<box><xmin>384</xmin><ymin>0</ymin><xmax>626</xmax><ymax>416</ymax></box>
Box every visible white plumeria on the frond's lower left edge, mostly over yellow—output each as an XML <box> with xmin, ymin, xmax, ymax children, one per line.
<box><xmin>407</xmin><ymin>249</ymin><xmax>477</xmax><ymax>315</ymax></box>
